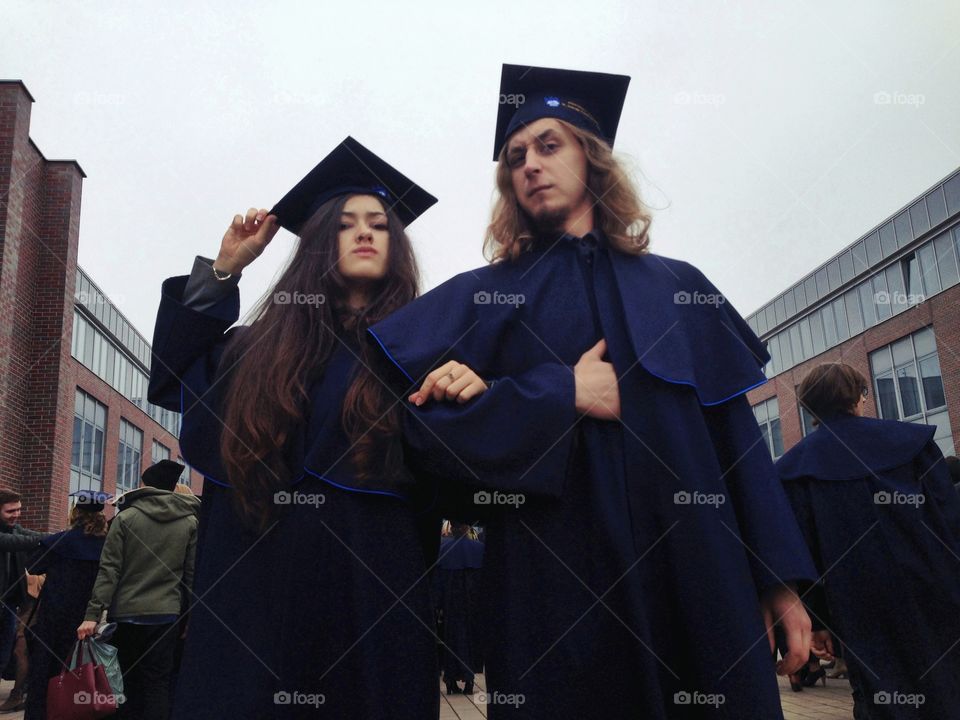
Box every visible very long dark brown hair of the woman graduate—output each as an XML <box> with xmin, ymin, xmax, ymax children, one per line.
<box><xmin>220</xmin><ymin>196</ymin><xmax>420</xmax><ymax>531</ymax></box>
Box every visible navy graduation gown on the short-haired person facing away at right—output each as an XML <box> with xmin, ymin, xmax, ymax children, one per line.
<box><xmin>777</xmin><ymin>415</ymin><xmax>960</xmax><ymax>720</ymax></box>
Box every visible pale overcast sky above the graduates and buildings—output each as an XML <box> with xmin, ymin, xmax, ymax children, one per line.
<box><xmin>0</xmin><ymin>0</ymin><xmax>960</xmax><ymax>339</ymax></box>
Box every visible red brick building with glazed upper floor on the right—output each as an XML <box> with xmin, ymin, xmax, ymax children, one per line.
<box><xmin>747</xmin><ymin>165</ymin><xmax>960</xmax><ymax>457</ymax></box>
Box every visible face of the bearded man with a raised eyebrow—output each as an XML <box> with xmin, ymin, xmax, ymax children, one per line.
<box><xmin>507</xmin><ymin>118</ymin><xmax>593</xmax><ymax>230</ymax></box>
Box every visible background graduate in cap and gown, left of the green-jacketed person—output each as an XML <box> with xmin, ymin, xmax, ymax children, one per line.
<box><xmin>24</xmin><ymin>490</ymin><xmax>113</xmax><ymax>720</ymax></box>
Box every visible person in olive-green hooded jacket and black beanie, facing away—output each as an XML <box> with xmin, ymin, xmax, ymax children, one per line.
<box><xmin>76</xmin><ymin>460</ymin><xmax>200</xmax><ymax>720</ymax></box>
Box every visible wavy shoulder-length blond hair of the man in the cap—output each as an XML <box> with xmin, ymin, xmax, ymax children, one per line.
<box><xmin>483</xmin><ymin>120</ymin><xmax>653</xmax><ymax>262</ymax></box>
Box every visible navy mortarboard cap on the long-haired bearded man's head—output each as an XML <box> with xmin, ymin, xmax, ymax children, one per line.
<box><xmin>493</xmin><ymin>64</ymin><xmax>630</xmax><ymax>160</ymax></box>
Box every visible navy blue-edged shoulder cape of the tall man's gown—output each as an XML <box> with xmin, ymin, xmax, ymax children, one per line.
<box><xmin>369</xmin><ymin>243</ymin><xmax>770</xmax><ymax>405</ymax></box>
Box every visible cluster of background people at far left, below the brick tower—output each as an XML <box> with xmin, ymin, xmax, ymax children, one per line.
<box><xmin>0</xmin><ymin>460</ymin><xmax>200</xmax><ymax>720</ymax></box>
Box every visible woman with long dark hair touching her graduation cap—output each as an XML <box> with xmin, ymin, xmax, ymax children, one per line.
<box><xmin>149</xmin><ymin>138</ymin><xmax>485</xmax><ymax>720</ymax></box>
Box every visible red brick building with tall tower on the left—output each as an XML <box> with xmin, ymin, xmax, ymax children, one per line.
<box><xmin>0</xmin><ymin>80</ymin><xmax>190</xmax><ymax>530</ymax></box>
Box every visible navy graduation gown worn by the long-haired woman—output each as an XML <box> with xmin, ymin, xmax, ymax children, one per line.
<box><xmin>149</xmin><ymin>277</ymin><xmax>439</xmax><ymax>720</ymax></box>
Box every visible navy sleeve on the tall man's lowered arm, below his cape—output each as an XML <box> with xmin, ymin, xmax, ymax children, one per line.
<box><xmin>703</xmin><ymin>395</ymin><xmax>817</xmax><ymax>592</ymax></box>
